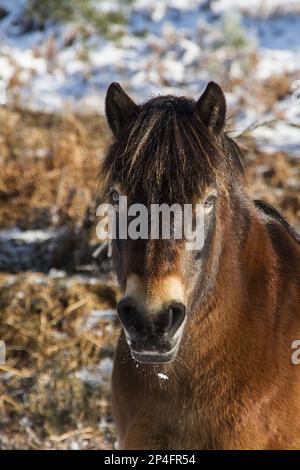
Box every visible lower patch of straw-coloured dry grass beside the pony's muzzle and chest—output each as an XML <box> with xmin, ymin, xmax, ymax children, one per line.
<box><xmin>0</xmin><ymin>273</ymin><xmax>117</xmax><ymax>448</ymax></box>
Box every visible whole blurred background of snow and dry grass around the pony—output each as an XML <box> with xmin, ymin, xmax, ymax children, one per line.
<box><xmin>0</xmin><ymin>0</ymin><xmax>300</xmax><ymax>450</ymax></box>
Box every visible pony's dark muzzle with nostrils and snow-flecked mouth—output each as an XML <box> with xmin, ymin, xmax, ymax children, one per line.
<box><xmin>117</xmin><ymin>297</ymin><xmax>186</xmax><ymax>364</ymax></box>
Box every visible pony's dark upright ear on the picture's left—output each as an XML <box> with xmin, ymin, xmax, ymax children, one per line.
<box><xmin>105</xmin><ymin>83</ymin><xmax>139</xmax><ymax>135</ymax></box>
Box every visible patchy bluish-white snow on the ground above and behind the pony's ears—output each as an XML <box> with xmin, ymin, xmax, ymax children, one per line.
<box><xmin>0</xmin><ymin>0</ymin><xmax>300</xmax><ymax>154</ymax></box>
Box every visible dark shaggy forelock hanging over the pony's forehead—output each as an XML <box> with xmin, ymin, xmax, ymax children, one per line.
<box><xmin>100</xmin><ymin>96</ymin><xmax>243</xmax><ymax>203</ymax></box>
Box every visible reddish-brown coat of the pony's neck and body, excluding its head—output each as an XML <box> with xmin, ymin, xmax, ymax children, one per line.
<box><xmin>113</xmin><ymin>204</ymin><xmax>300</xmax><ymax>449</ymax></box>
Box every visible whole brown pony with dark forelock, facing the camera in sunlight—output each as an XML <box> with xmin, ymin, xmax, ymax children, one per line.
<box><xmin>101</xmin><ymin>82</ymin><xmax>300</xmax><ymax>449</ymax></box>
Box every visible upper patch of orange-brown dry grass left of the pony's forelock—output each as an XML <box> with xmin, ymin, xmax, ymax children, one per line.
<box><xmin>0</xmin><ymin>108</ymin><xmax>107</xmax><ymax>228</ymax></box>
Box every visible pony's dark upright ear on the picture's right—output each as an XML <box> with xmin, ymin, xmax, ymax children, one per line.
<box><xmin>194</xmin><ymin>82</ymin><xmax>226</xmax><ymax>135</ymax></box>
